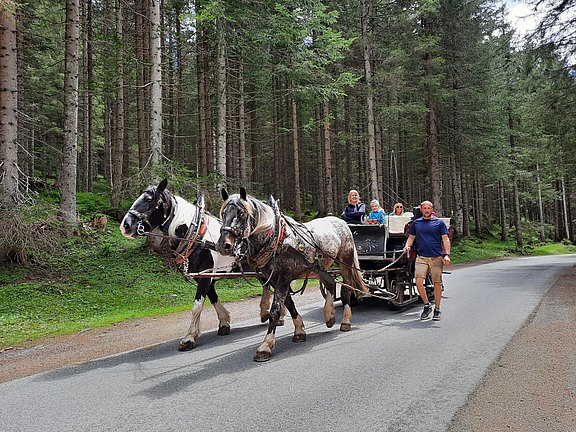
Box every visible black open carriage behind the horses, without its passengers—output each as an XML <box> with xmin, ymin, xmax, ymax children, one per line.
<box><xmin>349</xmin><ymin>216</ymin><xmax>452</xmax><ymax>309</ymax></box>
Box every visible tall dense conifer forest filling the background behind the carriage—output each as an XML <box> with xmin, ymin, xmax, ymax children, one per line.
<box><xmin>0</xmin><ymin>0</ymin><xmax>576</xmax><ymax>248</ymax></box>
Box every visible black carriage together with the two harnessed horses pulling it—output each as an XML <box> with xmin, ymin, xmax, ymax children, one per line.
<box><xmin>120</xmin><ymin>180</ymin><xmax>450</xmax><ymax>361</ymax></box>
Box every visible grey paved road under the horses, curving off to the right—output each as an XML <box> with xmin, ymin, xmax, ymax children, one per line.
<box><xmin>0</xmin><ymin>255</ymin><xmax>576</xmax><ymax>432</ymax></box>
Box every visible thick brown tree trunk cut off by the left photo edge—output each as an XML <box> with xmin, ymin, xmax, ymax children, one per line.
<box><xmin>0</xmin><ymin>1</ymin><xmax>18</xmax><ymax>208</ymax></box>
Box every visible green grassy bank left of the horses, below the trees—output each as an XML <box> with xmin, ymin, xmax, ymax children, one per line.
<box><xmin>0</xmin><ymin>225</ymin><xmax>261</xmax><ymax>349</ymax></box>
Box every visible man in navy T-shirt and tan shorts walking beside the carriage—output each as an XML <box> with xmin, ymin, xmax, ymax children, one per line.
<box><xmin>404</xmin><ymin>201</ymin><xmax>450</xmax><ymax>321</ymax></box>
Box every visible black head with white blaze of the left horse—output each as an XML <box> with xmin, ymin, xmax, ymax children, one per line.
<box><xmin>120</xmin><ymin>179</ymin><xmax>172</xmax><ymax>238</ymax></box>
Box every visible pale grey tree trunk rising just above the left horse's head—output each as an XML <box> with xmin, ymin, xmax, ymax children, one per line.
<box><xmin>150</xmin><ymin>0</ymin><xmax>162</xmax><ymax>165</ymax></box>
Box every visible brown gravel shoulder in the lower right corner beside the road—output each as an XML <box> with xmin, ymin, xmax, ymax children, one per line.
<box><xmin>449</xmin><ymin>267</ymin><xmax>576</xmax><ymax>432</ymax></box>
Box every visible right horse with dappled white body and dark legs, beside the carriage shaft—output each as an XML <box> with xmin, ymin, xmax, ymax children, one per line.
<box><xmin>217</xmin><ymin>187</ymin><xmax>368</xmax><ymax>362</ymax></box>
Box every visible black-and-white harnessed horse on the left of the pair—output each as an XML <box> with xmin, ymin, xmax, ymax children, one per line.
<box><xmin>120</xmin><ymin>179</ymin><xmax>282</xmax><ymax>351</ymax></box>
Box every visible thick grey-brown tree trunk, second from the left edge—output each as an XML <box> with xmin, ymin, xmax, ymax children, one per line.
<box><xmin>59</xmin><ymin>0</ymin><xmax>80</xmax><ymax>225</ymax></box>
